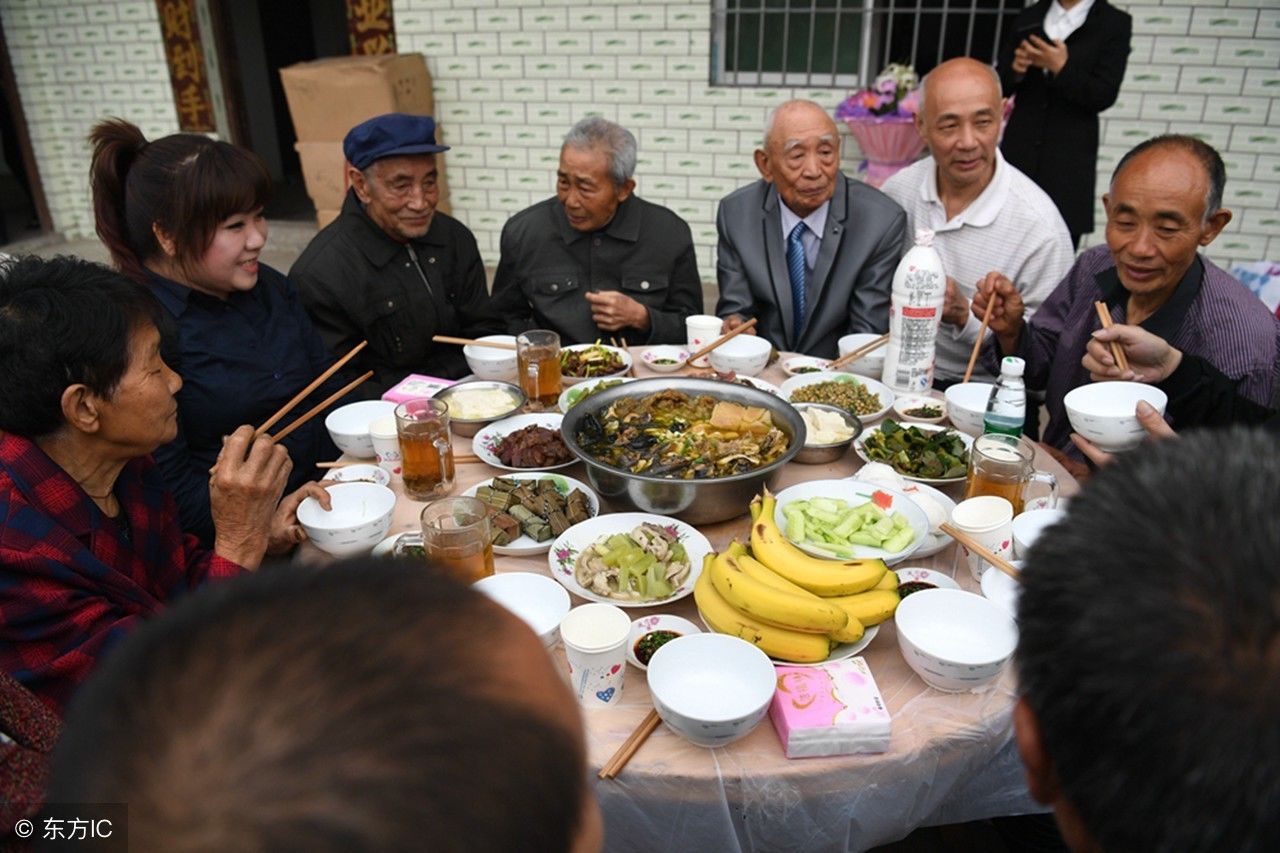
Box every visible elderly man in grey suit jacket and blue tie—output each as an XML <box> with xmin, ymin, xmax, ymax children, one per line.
<box><xmin>716</xmin><ymin>100</ymin><xmax>908</xmax><ymax>359</ymax></box>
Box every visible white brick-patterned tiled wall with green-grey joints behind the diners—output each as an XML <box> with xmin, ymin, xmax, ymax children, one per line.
<box><xmin>0</xmin><ymin>0</ymin><xmax>1280</xmax><ymax>270</ymax></box>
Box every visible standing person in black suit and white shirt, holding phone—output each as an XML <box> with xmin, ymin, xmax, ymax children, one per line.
<box><xmin>998</xmin><ymin>0</ymin><xmax>1133</xmax><ymax>247</ymax></box>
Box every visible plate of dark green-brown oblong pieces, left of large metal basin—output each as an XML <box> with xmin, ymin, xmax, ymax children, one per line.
<box><xmin>462</xmin><ymin>471</ymin><xmax>600</xmax><ymax>557</ymax></box>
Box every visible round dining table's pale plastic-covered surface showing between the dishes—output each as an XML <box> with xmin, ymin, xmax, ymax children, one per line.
<box><xmin>298</xmin><ymin>347</ymin><xmax>1076</xmax><ymax>853</ymax></box>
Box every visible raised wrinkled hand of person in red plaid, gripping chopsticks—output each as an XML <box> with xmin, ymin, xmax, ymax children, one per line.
<box><xmin>209</xmin><ymin>425</ymin><xmax>293</xmax><ymax>569</ymax></box>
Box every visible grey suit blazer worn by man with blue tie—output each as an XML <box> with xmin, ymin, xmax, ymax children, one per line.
<box><xmin>716</xmin><ymin>173</ymin><xmax>908</xmax><ymax>359</ymax></box>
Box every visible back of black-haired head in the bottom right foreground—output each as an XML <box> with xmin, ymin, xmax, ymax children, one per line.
<box><xmin>1015</xmin><ymin>429</ymin><xmax>1280</xmax><ymax>853</ymax></box>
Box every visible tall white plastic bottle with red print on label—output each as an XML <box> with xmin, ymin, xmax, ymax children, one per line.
<box><xmin>881</xmin><ymin>228</ymin><xmax>947</xmax><ymax>393</ymax></box>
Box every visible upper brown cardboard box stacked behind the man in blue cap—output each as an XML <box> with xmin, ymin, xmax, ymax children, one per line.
<box><xmin>280</xmin><ymin>54</ymin><xmax>435</xmax><ymax>142</ymax></box>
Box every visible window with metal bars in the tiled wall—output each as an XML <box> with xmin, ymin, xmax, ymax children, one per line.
<box><xmin>712</xmin><ymin>0</ymin><xmax>1029</xmax><ymax>87</ymax></box>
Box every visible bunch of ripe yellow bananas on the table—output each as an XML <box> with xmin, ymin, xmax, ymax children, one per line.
<box><xmin>694</xmin><ymin>489</ymin><xmax>899</xmax><ymax>663</ymax></box>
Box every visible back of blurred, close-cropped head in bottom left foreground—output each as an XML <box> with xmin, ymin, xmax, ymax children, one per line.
<box><xmin>49</xmin><ymin>558</ymin><xmax>594</xmax><ymax>853</ymax></box>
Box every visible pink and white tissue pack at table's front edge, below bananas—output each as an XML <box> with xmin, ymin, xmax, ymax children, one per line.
<box><xmin>769</xmin><ymin>657</ymin><xmax>890</xmax><ymax>758</ymax></box>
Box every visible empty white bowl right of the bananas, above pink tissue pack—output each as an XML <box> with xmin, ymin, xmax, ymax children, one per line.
<box><xmin>890</xmin><ymin>589</ymin><xmax>1018</xmax><ymax>693</ymax></box>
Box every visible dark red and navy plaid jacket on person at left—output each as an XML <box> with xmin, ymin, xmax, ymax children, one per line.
<box><xmin>0</xmin><ymin>435</ymin><xmax>244</xmax><ymax>708</ymax></box>
